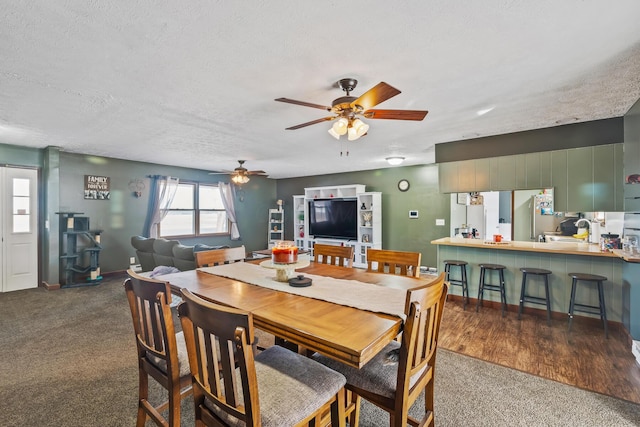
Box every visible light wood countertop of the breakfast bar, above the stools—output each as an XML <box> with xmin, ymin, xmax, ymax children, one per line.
<box><xmin>431</xmin><ymin>237</ymin><xmax>620</xmax><ymax>262</ymax></box>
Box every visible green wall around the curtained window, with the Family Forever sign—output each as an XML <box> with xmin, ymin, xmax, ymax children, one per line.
<box><xmin>57</xmin><ymin>153</ymin><xmax>276</xmax><ymax>278</ymax></box>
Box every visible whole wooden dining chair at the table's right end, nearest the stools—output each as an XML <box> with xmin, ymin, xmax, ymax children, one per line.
<box><xmin>313</xmin><ymin>273</ymin><xmax>448</xmax><ymax>427</ymax></box>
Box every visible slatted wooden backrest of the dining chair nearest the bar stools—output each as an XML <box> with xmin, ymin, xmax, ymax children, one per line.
<box><xmin>396</xmin><ymin>273</ymin><xmax>448</xmax><ymax>407</ymax></box>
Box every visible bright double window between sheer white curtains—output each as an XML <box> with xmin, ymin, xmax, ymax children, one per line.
<box><xmin>158</xmin><ymin>182</ymin><xmax>229</xmax><ymax>237</ymax></box>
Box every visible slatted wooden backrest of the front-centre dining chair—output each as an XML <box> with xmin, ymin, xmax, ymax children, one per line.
<box><xmin>178</xmin><ymin>290</ymin><xmax>260</xmax><ymax>426</ymax></box>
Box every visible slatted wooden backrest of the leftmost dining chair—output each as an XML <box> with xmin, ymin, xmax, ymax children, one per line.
<box><xmin>124</xmin><ymin>270</ymin><xmax>180</xmax><ymax>390</ymax></box>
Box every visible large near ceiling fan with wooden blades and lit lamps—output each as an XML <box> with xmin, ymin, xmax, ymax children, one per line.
<box><xmin>276</xmin><ymin>78</ymin><xmax>428</xmax><ymax>141</ymax></box>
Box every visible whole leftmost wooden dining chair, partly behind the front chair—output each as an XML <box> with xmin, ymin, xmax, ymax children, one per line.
<box><xmin>124</xmin><ymin>270</ymin><xmax>192</xmax><ymax>427</ymax></box>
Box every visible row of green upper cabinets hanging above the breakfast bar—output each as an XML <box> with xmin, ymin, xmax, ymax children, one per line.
<box><xmin>438</xmin><ymin>144</ymin><xmax>624</xmax><ymax>212</ymax></box>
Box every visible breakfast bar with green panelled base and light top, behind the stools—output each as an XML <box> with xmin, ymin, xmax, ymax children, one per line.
<box><xmin>431</xmin><ymin>237</ymin><xmax>624</xmax><ymax>322</ymax></box>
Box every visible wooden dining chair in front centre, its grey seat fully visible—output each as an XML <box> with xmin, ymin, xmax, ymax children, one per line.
<box><xmin>178</xmin><ymin>289</ymin><xmax>346</xmax><ymax>427</ymax></box>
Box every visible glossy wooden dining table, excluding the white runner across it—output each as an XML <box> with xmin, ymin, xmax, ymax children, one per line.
<box><xmin>156</xmin><ymin>262</ymin><xmax>436</xmax><ymax>368</ymax></box>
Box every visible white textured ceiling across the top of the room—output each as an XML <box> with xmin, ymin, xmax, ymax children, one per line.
<box><xmin>0</xmin><ymin>0</ymin><xmax>640</xmax><ymax>178</ymax></box>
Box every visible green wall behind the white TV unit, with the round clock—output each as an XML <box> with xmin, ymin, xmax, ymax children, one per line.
<box><xmin>278</xmin><ymin>165</ymin><xmax>451</xmax><ymax>267</ymax></box>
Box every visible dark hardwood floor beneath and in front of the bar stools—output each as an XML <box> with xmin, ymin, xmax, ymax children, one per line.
<box><xmin>438</xmin><ymin>297</ymin><xmax>640</xmax><ymax>404</ymax></box>
